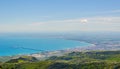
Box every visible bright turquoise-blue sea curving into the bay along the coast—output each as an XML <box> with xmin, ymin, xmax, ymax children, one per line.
<box><xmin>0</xmin><ymin>37</ymin><xmax>90</xmax><ymax>56</ymax></box>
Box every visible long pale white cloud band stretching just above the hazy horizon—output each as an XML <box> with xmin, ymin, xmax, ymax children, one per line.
<box><xmin>0</xmin><ymin>17</ymin><xmax>120</xmax><ymax>32</ymax></box>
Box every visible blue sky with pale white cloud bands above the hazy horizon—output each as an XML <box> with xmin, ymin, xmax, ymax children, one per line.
<box><xmin>0</xmin><ymin>0</ymin><xmax>120</xmax><ymax>33</ymax></box>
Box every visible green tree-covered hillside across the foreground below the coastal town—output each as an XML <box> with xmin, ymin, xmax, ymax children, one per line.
<box><xmin>0</xmin><ymin>51</ymin><xmax>120</xmax><ymax>69</ymax></box>
